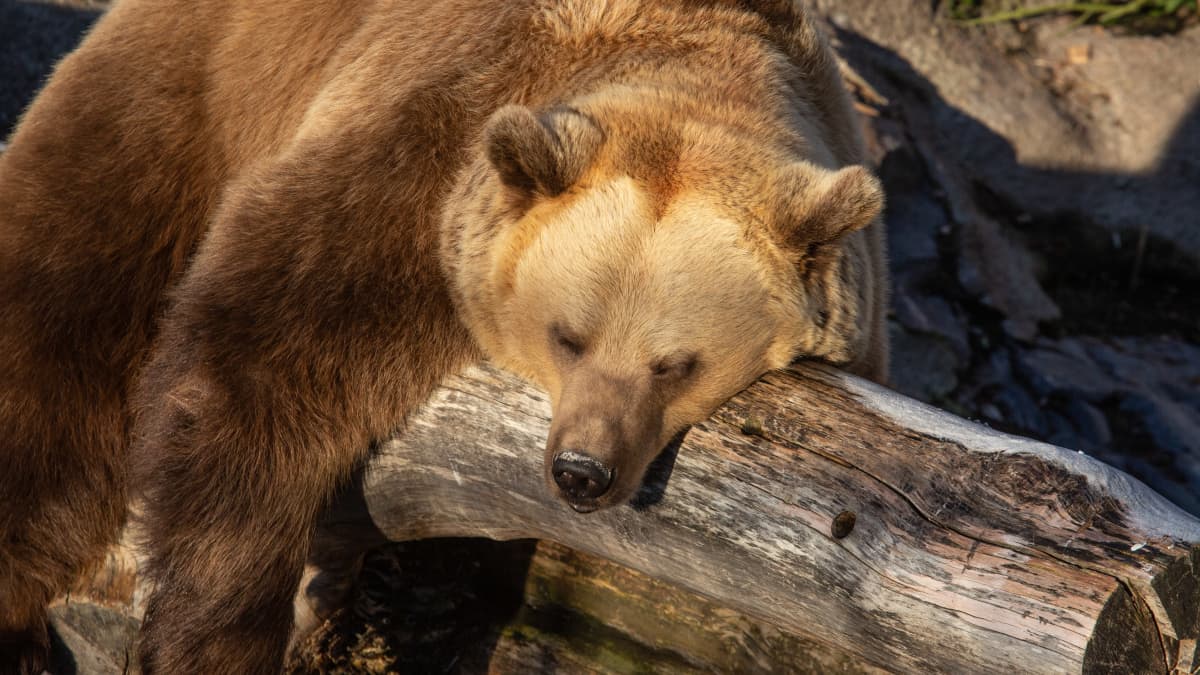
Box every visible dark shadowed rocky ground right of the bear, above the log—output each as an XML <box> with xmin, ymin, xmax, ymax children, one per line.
<box><xmin>839</xmin><ymin>26</ymin><xmax>1200</xmax><ymax>514</ymax></box>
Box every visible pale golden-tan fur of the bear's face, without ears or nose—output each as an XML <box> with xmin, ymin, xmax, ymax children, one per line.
<box><xmin>496</xmin><ymin>177</ymin><xmax>791</xmax><ymax>503</ymax></box>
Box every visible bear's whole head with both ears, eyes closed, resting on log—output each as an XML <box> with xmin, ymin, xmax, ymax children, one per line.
<box><xmin>443</xmin><ymin>104</ymin><xmax>883</xmax><ymax>512</ymax></box>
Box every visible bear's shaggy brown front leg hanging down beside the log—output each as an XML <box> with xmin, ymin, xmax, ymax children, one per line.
<box><xmin>133</xmin><ymin>142</ymin><xmax>474</xmax><ymax>674</ymax></box>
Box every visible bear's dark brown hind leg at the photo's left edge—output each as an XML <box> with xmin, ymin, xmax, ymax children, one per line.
<box><xmin>0</xmin><ymin>3</ymin><xmax>218</xmax><ymax>674</ymax></box>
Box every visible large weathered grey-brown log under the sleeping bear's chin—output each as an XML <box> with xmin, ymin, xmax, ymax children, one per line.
<box><xmin>56</xmin><ymin>366</ymin><xmax>1200</xmax><ymax>674</ymax></box>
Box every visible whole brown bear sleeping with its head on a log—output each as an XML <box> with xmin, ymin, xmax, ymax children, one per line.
<box><xmin>0</xmin><ymin>0</ymin><xmax>887</xmax><ymax>673</ymax></box>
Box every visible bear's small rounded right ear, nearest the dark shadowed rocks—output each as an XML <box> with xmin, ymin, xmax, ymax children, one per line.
<box><xmin>767</xmin><ymin>162</ymin><xmax>883</xmax><ymax>251</ymax></box>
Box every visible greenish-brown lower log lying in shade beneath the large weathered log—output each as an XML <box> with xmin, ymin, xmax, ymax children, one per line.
<box><xmin>480</xmin><ymin>540</ymin><xmax>887</xmax><ymax>675</ymax></box>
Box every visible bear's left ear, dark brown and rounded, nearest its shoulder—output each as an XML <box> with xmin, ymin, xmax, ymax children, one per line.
<box><xmin>484</xmin><ymin>106</ymin><xmax>604</xmax><ymax>197</ymax></box>
